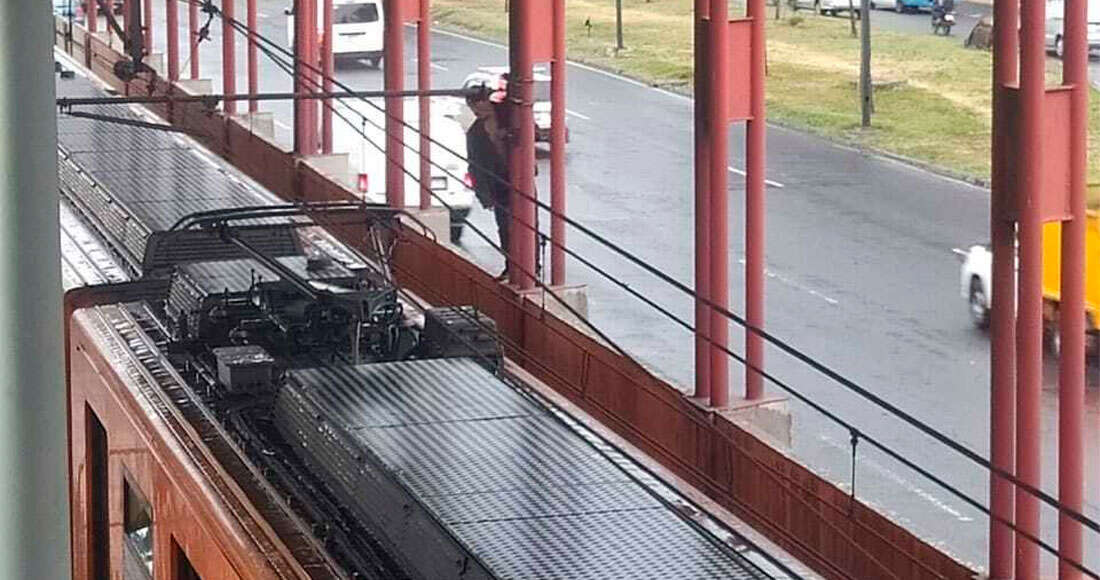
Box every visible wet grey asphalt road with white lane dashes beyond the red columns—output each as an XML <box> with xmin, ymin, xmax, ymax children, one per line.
<box><xmin>130</xmin><ymin>0</ymin><xmax>1100</xmax><ymax>567</ymax></box>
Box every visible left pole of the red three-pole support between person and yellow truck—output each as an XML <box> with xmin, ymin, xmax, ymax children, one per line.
<box><xmin>694</xmin><ymin>0</ymin><xmax>711</xmax><ymax>402</ymax></box>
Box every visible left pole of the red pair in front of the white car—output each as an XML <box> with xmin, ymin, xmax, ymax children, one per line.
<box><xmin>383</xmin><ymin>0</ymin><xmax>405</xmax><ymax>209</ymax></box>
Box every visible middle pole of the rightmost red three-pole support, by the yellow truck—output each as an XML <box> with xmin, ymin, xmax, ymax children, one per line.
<box><xmin>1012</xmin><ymin>0</ymin><xmax>1046</xmax><ymax>579</ymax></box>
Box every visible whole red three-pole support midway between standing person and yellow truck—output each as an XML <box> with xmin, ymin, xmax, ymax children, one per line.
<box><xmin>694</xmin><ymin>0</ymin><xmax>767</xmax><ymax>407</ymax></box>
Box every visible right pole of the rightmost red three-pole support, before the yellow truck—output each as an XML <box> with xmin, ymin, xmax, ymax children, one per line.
<box><xmin>1056</xmin><ymin>0</ymin><xmax>1089</xmax><ymax>580</ymax></box>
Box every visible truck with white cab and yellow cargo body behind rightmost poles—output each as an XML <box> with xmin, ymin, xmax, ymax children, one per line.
<box><xmin>955</xmin><ymin>211</ymin><xmax>1100</xmax><ymax>351</ymax></box>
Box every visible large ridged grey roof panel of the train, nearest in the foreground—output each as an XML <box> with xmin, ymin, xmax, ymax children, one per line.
<box><xmin>282</xmin><ymin>359</ymin><xmax>762</xmax><ymax>579</ymax></box>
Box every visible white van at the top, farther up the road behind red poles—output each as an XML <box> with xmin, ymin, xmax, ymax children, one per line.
<box><xmin>283</xmin><ymin>0</ymin><xmax>384</xmax><ymax>68</ymax></box>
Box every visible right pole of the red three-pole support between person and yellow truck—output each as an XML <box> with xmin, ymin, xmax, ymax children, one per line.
<box><xmin>745</xmin><ymin>0</ymin><xmax>768</xmax><ymax>401</ymax></box>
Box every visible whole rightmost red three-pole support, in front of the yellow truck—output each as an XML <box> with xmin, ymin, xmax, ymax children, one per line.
<box><xmin>989</xmin><ymin>0</ymin><xmax>1089</xmax><ymax>579</ymax></box>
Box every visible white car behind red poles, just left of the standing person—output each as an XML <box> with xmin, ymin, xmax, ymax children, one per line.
<box><xmin>332</xmin><ymin>98</ymin><xmax>474</xmax><ymax>242</ymax></box>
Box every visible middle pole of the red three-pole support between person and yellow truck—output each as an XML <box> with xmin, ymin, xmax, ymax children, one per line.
<box><xmin>707</xmin><ymin>1</ymin><xmax>729</xmax><ymax>407</ymax></box>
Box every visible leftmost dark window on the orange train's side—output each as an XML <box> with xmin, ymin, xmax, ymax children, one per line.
<box><xmin>85</xmin><ymin>405</ymin><xmax>111</xmax><ymax>580</ymax></box>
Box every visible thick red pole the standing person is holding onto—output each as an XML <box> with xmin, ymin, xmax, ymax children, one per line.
<box><xmin>508</xmin><ymin>0</ymin><xmax>539</xmax><ymax>289</ymax></box>
